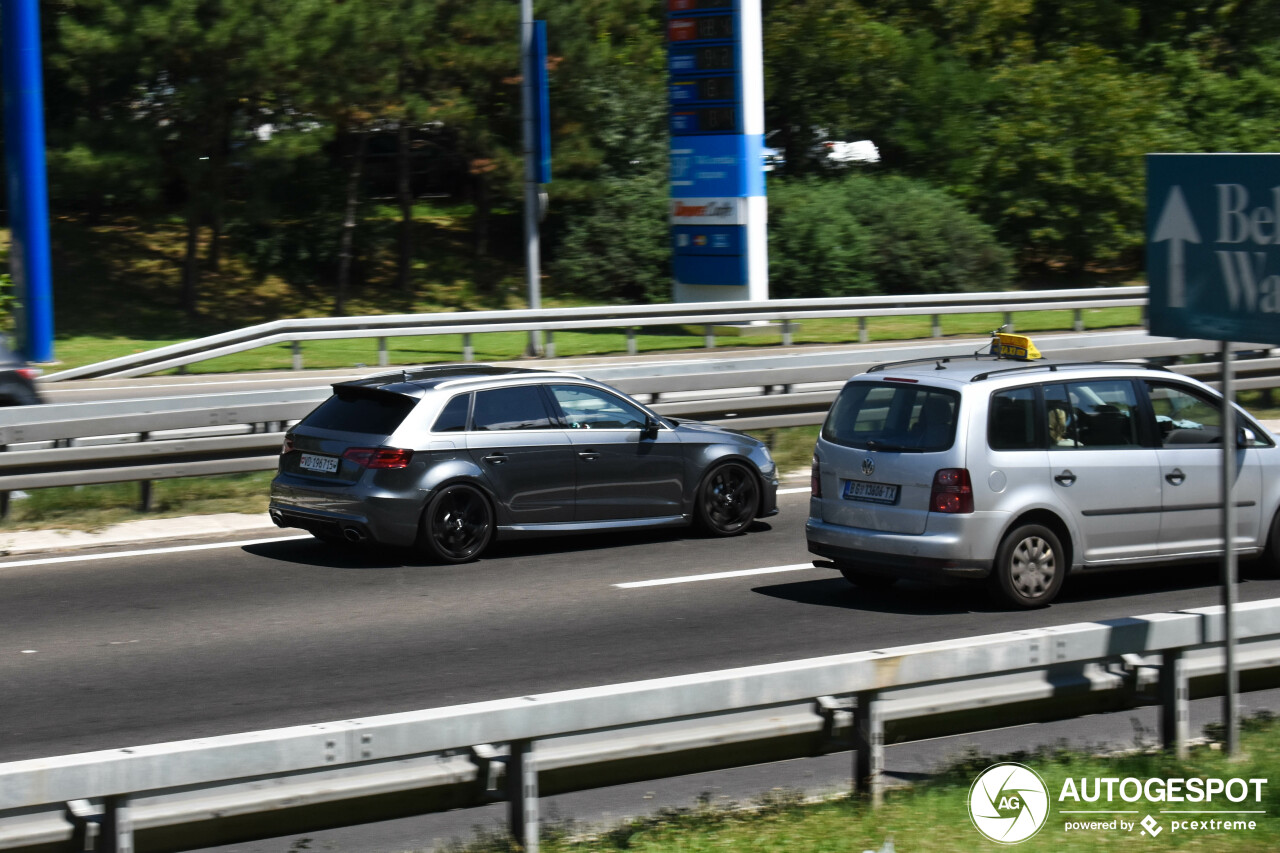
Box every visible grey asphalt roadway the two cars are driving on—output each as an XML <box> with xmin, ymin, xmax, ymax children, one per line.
<box><xmin>0</xmin><ymin>492</ymin><xmax>1280</xmax><ymax>761</ymax></box>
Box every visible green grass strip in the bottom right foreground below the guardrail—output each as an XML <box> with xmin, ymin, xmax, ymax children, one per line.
<box><xmin>454</xmin><ymin>716</ymin><xmax>1280</xmax><ymax>853</ymax></box>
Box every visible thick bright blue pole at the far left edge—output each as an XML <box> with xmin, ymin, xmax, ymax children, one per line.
<box><xmin>0</xmin><ymin>0</ymin><xmax>54</xmax><ymax>364</ymax></box>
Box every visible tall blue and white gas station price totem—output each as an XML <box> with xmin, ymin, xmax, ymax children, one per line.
<box><xmin>667</xmin><ymin>0</ymin><xmax>768</xmax><ymax>302</ymax></box>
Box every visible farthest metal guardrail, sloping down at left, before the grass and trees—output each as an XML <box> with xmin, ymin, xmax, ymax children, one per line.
<box><xmin>45</xmin><ymin>286</ymin><xmax>1147</xmax><ymax>382</ymax></box>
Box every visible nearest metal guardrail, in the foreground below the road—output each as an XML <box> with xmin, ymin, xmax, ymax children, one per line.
<box><xmin>0</xmin><ymin>599</ymin><xmax>1280</xmax><ymax>853</ymax></box>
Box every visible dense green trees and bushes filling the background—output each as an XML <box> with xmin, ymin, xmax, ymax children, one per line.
<box><xmin>7</xmin><ymin>0</ymin><xmax>1280</xmax><ymax>322</ymax></box>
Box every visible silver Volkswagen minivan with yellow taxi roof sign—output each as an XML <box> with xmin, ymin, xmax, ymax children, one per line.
<box><xmin>805</xmin><ymin>356</ymin><xmax>1280</xmax><ymax>607</ymax></box>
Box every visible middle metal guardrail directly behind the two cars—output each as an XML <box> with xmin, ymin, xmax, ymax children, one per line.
<box><xmin>0</xmin><ymin>330</ymin><xmax>1280</xmax><ymax>491</ymax></box>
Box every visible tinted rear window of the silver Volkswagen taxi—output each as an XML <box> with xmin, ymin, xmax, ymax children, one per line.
<box><xmin>822</xmin><ymin>382</ymin><xmax>960</xmax><ymax>453</ymax></box>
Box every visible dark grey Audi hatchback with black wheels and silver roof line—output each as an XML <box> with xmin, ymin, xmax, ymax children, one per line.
<box><xmin>270</xmin><ymin>365</ymin><xmax>778</xmax><ymax>564</ymax></box>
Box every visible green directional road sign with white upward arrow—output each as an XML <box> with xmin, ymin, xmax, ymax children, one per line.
<box><xmin>1147</xmin><ymin>154</ymin><xmax>1280</xmax><ymax>345</ymax></box>
